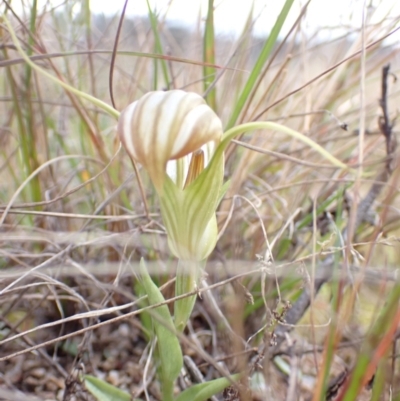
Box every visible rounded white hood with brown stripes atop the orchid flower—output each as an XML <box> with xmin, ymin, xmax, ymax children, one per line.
<box><xmin>118</xmin><ymin>90</ymin><xmax>223</xmax><ymax>192</ymax></box>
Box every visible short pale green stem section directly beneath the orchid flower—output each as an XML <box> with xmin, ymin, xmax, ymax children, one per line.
<box><xmin>174</xmin><ymin>259</ymin><xmax>205</xmax><ymax>332</ymax></box>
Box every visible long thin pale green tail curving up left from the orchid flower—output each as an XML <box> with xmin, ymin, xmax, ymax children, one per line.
<box><xmin>3</xmin><ymin>15</ymin><xmax>120</xmax><ymax>118</ymax></box>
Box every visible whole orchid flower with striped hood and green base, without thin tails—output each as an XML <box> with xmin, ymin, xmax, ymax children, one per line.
<box><xmin>118</xmin><ymin>90</ymin><xmax>224</xmax><ymax>261</ymax></box>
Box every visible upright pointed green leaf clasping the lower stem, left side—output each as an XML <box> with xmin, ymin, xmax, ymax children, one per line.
<box><xmin>140</xmin><ymin>258</ymin><xmax>183</xmax><ymax>386</ymax></box>
